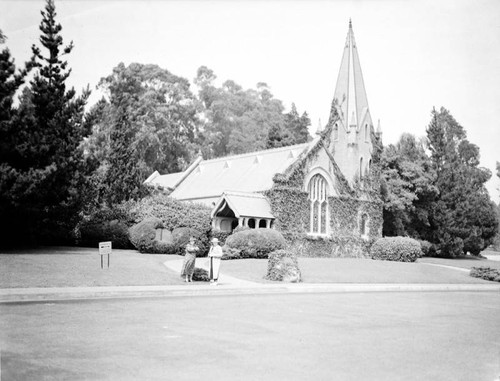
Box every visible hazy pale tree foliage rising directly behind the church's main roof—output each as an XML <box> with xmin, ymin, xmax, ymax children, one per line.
<box><xmin>194</xmin><ymin>66</ymin><xmax>308</xmax><ymax>158</ymax></box>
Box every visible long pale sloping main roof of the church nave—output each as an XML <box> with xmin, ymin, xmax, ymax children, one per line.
<box><xmin>145</xmin><ymin>142</ymin><xmax>313</xmax><ymax>200</ymax></box>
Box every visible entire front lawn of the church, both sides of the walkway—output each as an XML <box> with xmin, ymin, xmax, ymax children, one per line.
<box><xmin>0</xmin><ymin>247</ymin><xmax>500</xmax><ymax>288</ymax></box>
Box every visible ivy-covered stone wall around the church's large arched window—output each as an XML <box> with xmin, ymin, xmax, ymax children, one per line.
<box><xmin>265</xmin><ymin>132</ymin><xmax>383</xmax><ymax>258</ymax></box>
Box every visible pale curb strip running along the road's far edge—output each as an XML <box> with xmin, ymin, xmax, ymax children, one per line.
<box><xmin>0</xmin><ymin>283</ymin><xmax>500</xmax><ymax>304</ymax></box>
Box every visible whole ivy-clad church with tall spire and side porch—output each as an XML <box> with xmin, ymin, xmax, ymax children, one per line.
<box><xmin>145</xmin><ymin>21</ymin><xmax>382</xmax><ymax>257</ymax></box>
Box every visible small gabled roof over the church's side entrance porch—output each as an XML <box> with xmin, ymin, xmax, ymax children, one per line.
<box><xmin>211</xmin><ymin>192</ymin><xmax>274</xmax><ymax>218</ymax></box>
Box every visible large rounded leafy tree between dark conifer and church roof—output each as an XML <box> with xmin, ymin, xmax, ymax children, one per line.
<box><xmin>86</xmin><ymin>63</ymin><xmax>198</xmax><ymax>204</ymax></box>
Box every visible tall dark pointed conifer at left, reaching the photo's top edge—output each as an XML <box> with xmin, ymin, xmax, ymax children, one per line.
<box><xmin>1</xmin><ymin>0</ymin><xmax>89</xmax><ymax>242</ymax></box>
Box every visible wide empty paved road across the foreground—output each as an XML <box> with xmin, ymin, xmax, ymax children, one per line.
<box><xmin>0</xmin><ymin>292</ymin><xmax>500</xmax><ymax>381</ymax></box>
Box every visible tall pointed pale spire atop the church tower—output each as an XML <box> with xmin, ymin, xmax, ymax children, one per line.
<box><xmin>334</xmin><ymin>19</ymin><xmax>371</xmax><ymax>130</ymax></box>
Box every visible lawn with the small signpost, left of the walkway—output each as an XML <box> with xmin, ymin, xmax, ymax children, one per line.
<box><xmin>0</xmin><ymin>247</ymin><xmax>182</xmax><ymax>288</ymax></box>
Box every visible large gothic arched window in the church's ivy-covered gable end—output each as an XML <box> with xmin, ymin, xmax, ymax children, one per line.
<box><xmin>308</xmin><ymin>174</ymin><xmax>329</xmax><ymax>235</ymax></box>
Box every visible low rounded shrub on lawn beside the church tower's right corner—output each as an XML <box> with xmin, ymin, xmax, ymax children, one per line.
<box><xmin>371</xmin><ymin>237</ymin><xmax>422</xmax><ymax>262</ymax></box>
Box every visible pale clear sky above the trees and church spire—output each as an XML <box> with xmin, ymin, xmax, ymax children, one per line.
<box><xmin>0</xmin><ymin>0</ymin><xmax>500</xmax><ymax>203</ymax></box>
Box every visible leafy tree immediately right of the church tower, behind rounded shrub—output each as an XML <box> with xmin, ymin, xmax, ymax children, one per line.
<box><xmin>381</xmin><ymin>133</ymin><xmax>438</xmax><ymax>239</ymax></box>
